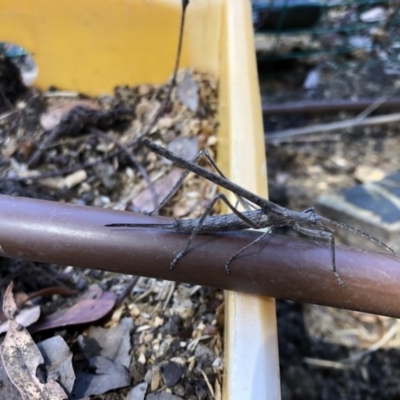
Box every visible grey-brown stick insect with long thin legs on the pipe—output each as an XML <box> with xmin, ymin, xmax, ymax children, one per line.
<box><xmin>106</xmin><ymin>139</ymin><xmax>398</xmax><ymax>287</ymax></box>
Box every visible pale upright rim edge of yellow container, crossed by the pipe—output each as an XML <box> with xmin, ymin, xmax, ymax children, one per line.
<box><xmin>218</xmin><ymin>0</ymin><xmax>281</xmax><ymax>400</ymax></box>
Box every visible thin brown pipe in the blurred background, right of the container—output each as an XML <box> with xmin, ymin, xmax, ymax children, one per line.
<box><xmin>262</xmin><ymin>97</ymin><xmax>400</xmax><ymax>115</ymax></box>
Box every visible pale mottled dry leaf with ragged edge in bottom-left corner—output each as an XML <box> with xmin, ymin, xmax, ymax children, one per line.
<box><xmin>1</xmin><ymin>283</ymin><xmax>68</xmax><ymax>400</ymax></box>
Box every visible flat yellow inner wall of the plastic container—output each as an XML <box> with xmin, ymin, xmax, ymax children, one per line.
<box><xmin>0</xmin><ymin>0</ymin><xmax>223</xmax><ymax>95</ymax></box>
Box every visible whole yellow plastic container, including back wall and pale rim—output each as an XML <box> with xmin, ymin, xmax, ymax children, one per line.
<box><xmin>0</xmin><ymin>0</ymin><xmax>280</xmax><ymax>400</ymax></box>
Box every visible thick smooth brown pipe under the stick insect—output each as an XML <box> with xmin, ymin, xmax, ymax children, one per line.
<box><xmin>0</xmin><ymin>196</ymin><xmax>400</xmax><ymax>317</ymax></box>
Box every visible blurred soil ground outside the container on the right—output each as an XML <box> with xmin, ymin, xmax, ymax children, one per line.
<box><xmin>260</xmin><ymin>57</ymin><xmax>400</xmax><ymax>400</ymax></box>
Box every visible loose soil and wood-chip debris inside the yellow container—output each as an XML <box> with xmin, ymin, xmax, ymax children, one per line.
<box><xmin>0</xmin><ymin>72</ymin><xmax>223</xmax><ymax>400</ymax></box>
